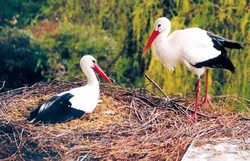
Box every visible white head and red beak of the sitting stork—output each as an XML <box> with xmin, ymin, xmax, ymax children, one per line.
<box><xmin>80</xmin><ymin>55</ymin><xmax>111</xmax><ymax>83</ymax></box>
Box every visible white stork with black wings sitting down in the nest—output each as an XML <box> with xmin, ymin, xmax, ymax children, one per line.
<box><xmin>28</xmin><ymin>55</ymin><xmax>111</xmax><ymax>124</ymax></box>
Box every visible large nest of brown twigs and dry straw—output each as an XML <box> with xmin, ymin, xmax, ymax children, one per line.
<box><xmin>0</xmin><ymin>80</ymin><xmax>250</xmax><ymax>160</ymax></box>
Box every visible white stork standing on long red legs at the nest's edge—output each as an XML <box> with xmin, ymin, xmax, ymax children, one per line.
<box><xmin>144</xmin><ymin>17</ymin><xmax>242</xmax><ymax>122</ymax></box>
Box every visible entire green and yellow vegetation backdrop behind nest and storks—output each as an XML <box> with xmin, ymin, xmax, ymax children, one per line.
<box><xmin>0</xmin><ymin>0</ymin><xmax>250</xmax><ymax>98</ymax></box>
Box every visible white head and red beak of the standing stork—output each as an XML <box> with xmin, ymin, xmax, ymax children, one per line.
<box><xmin>143</xmin><ymin>17</ymin><xmax>171</xmax><ymax>52</ymax></box>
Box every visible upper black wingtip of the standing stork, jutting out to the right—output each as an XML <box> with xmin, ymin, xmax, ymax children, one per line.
<box><xmin>207</xmin><ymin>31</ymin><xmax>243</xmax><ymax>49</ymax></box>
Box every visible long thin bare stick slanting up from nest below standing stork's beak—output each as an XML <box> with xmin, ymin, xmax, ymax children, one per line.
<box><xmin>145</xmin><ymin>74</ymin><xmax>213</xmax><ymax>118</ymax></box>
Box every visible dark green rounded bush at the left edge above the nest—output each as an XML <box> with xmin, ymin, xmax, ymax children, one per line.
<box><xmin>0</xmin><ymin>27</ymin><xmax>46</xmax><ymax>89</ymax></box>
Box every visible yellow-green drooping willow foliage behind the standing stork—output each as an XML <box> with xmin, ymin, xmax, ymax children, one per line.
<box><xmin>37</xmin><ymin>0</ymin><xmax>250</xmax><ymax>97</ymax></box>
